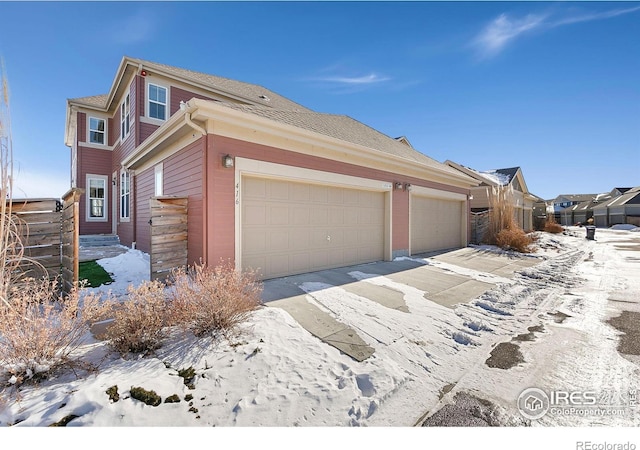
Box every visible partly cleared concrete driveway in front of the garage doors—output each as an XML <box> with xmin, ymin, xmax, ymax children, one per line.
<box><xmin>262</xmin><ymin>247</ymin><xmax>541</xmax><ymax>361</ymax></box>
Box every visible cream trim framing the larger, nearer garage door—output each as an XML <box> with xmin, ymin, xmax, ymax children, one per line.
<box><xmin>235</xmin><ymin>157</ymin><xmax>393</xmax><ymax>268</ymax></box>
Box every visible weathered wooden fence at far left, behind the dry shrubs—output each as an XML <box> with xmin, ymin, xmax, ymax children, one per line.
<box><xmin>6</xmin><ymin>189</ymin><xmax>84</xmax><ymax>293</ymax></box>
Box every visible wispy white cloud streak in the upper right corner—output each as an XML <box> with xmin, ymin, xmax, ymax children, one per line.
<box><xmin>472</xmin><ymin>6</ymin><xmax>640</xmax><ymax>59</ymax></box>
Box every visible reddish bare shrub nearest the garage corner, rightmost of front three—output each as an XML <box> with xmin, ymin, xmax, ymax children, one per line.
<box><xmin>170</xmin><ymin>262</ymin><xmax>262</xmax><ymax>337</ymax></box>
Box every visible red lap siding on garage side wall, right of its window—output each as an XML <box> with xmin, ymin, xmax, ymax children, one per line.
<box><xmin>163</xmin><ymin>139</ymin><xmax>204</xmax><ymax>264</ymax></box>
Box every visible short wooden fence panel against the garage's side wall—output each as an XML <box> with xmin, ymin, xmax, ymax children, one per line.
<box><xmin>149</xmin><ymin>197</ymin><xmax>188</xmax><ymax>280</ymax></box>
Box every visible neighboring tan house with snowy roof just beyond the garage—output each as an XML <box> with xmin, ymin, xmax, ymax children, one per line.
<box><xmin>444</xmin><ymin>160</ymin><xmax>542</xmax><ymax>231</ymax></box>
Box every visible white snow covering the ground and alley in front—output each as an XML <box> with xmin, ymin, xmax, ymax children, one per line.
<box><xmin>0</xmin><ymin>227</ymin><xmax>640</xmax><ymax>448</ymax></box>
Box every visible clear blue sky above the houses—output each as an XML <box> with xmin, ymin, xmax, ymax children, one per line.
<box><xmin>0</xmin><ymin>1</ymin><xmax>640</xmax><ymax>199</ymax></box>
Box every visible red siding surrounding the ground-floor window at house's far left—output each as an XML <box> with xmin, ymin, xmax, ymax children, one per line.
<box><xmin>77</xmin><ymin>147</ymin><xmax>114</xmax><ymax>234</ymax></box>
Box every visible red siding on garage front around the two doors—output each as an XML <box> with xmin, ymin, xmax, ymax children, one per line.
<box><xmin>206</xmin><ymin>135</ymin><xmax>468</xmax><ymax>261</ymax></box>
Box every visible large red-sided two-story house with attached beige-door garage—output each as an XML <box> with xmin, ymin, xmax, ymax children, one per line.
<box><xmin>65</xmin><ymin>57</ymin><xmax>477</xmax><ymax>278</ymax></box>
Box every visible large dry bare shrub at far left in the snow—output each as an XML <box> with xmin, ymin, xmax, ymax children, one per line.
<box><xmin>0</xmin><ymin>278</ymin><xmax>102</xmax><ymax>385</ymax></box>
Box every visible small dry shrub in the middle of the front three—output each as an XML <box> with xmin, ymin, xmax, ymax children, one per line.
<box><xmin>104</xmin><ymin>280</ymin><xmax>168</xmax><ymax>354</ymax></box>
